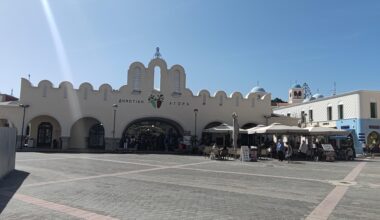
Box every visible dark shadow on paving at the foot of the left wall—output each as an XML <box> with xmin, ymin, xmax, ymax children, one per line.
<box><xmin>0</xmin><ymin>170</ymin><xmax>29</xmax><ymax>214</ymax></box>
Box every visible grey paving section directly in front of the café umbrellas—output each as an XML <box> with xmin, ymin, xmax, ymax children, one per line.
<box><xmin>183</xmin><ymin>161</ymin><xmax>352</xmax><ymax>180</ymax></box>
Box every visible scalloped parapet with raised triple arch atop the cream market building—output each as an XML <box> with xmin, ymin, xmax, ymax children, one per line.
<box><xmin>21</xmin><ymin>58</ymin><xmax>271</xmax><ymax>107</ymax></box>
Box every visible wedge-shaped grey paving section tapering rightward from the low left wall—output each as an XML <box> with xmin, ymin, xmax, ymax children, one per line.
<box><xmin>16</xmin><ymin>159</ymin><xmax>152</xmax><ymax>184</ymax></box>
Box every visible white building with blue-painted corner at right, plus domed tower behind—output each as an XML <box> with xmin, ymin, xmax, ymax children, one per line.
<box><xmin>274</xmin><ymin>85</ymin><xmax>380</xmax><ymax>153</ymax></box>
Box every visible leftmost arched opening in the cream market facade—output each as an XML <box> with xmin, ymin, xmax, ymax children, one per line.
<box><xmin>24</xmin><ymin>115</ymin><xmax>61</xmax><ymax>148</ymax></box>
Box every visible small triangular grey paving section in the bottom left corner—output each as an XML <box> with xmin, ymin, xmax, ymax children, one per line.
<box><xmin>0</xmin><ymin>196</ymin><xmax>77</xmax><ymax>220</ymax></box>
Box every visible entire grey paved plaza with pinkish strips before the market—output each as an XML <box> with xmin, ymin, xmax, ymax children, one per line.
<box><xmin>0</xmin><ymin>152</ymin><xmax>380</xmax><ymax>220</ymax></box>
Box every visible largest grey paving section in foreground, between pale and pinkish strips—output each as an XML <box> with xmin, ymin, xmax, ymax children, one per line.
<box><xmin>15</xmin><ymin>177</ymin><xmax>316</xmax><ymax>219</ymax></box>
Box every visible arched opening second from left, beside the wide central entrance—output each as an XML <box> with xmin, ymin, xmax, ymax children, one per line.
<box><xmin>70</xmin><ymin>117</ymin><xmax>105</xmax><ymax>149</ymax></box>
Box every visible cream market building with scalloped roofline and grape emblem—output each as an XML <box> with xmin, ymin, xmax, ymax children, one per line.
<box><xmin>0</xmin><ymin>56</ymin><xmax>296</xmax><ymax>151</ymax></box>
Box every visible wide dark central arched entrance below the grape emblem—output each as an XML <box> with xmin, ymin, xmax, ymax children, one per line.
<box><xmin>120</xmin><ymin>118</ymin><xmax>183</xmax><ymax>151</ymax></box>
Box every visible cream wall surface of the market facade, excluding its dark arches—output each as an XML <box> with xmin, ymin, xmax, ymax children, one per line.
<box><xmin>0</xmin><ymin>59</ymin><xmax>284</xmax><ymax>149</ymax></box>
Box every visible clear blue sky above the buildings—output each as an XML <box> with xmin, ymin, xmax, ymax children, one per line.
<box><xmin>0</xmin><ymin>0</ymin><xmax>380</xmax><ymax>99</ymax></box>
